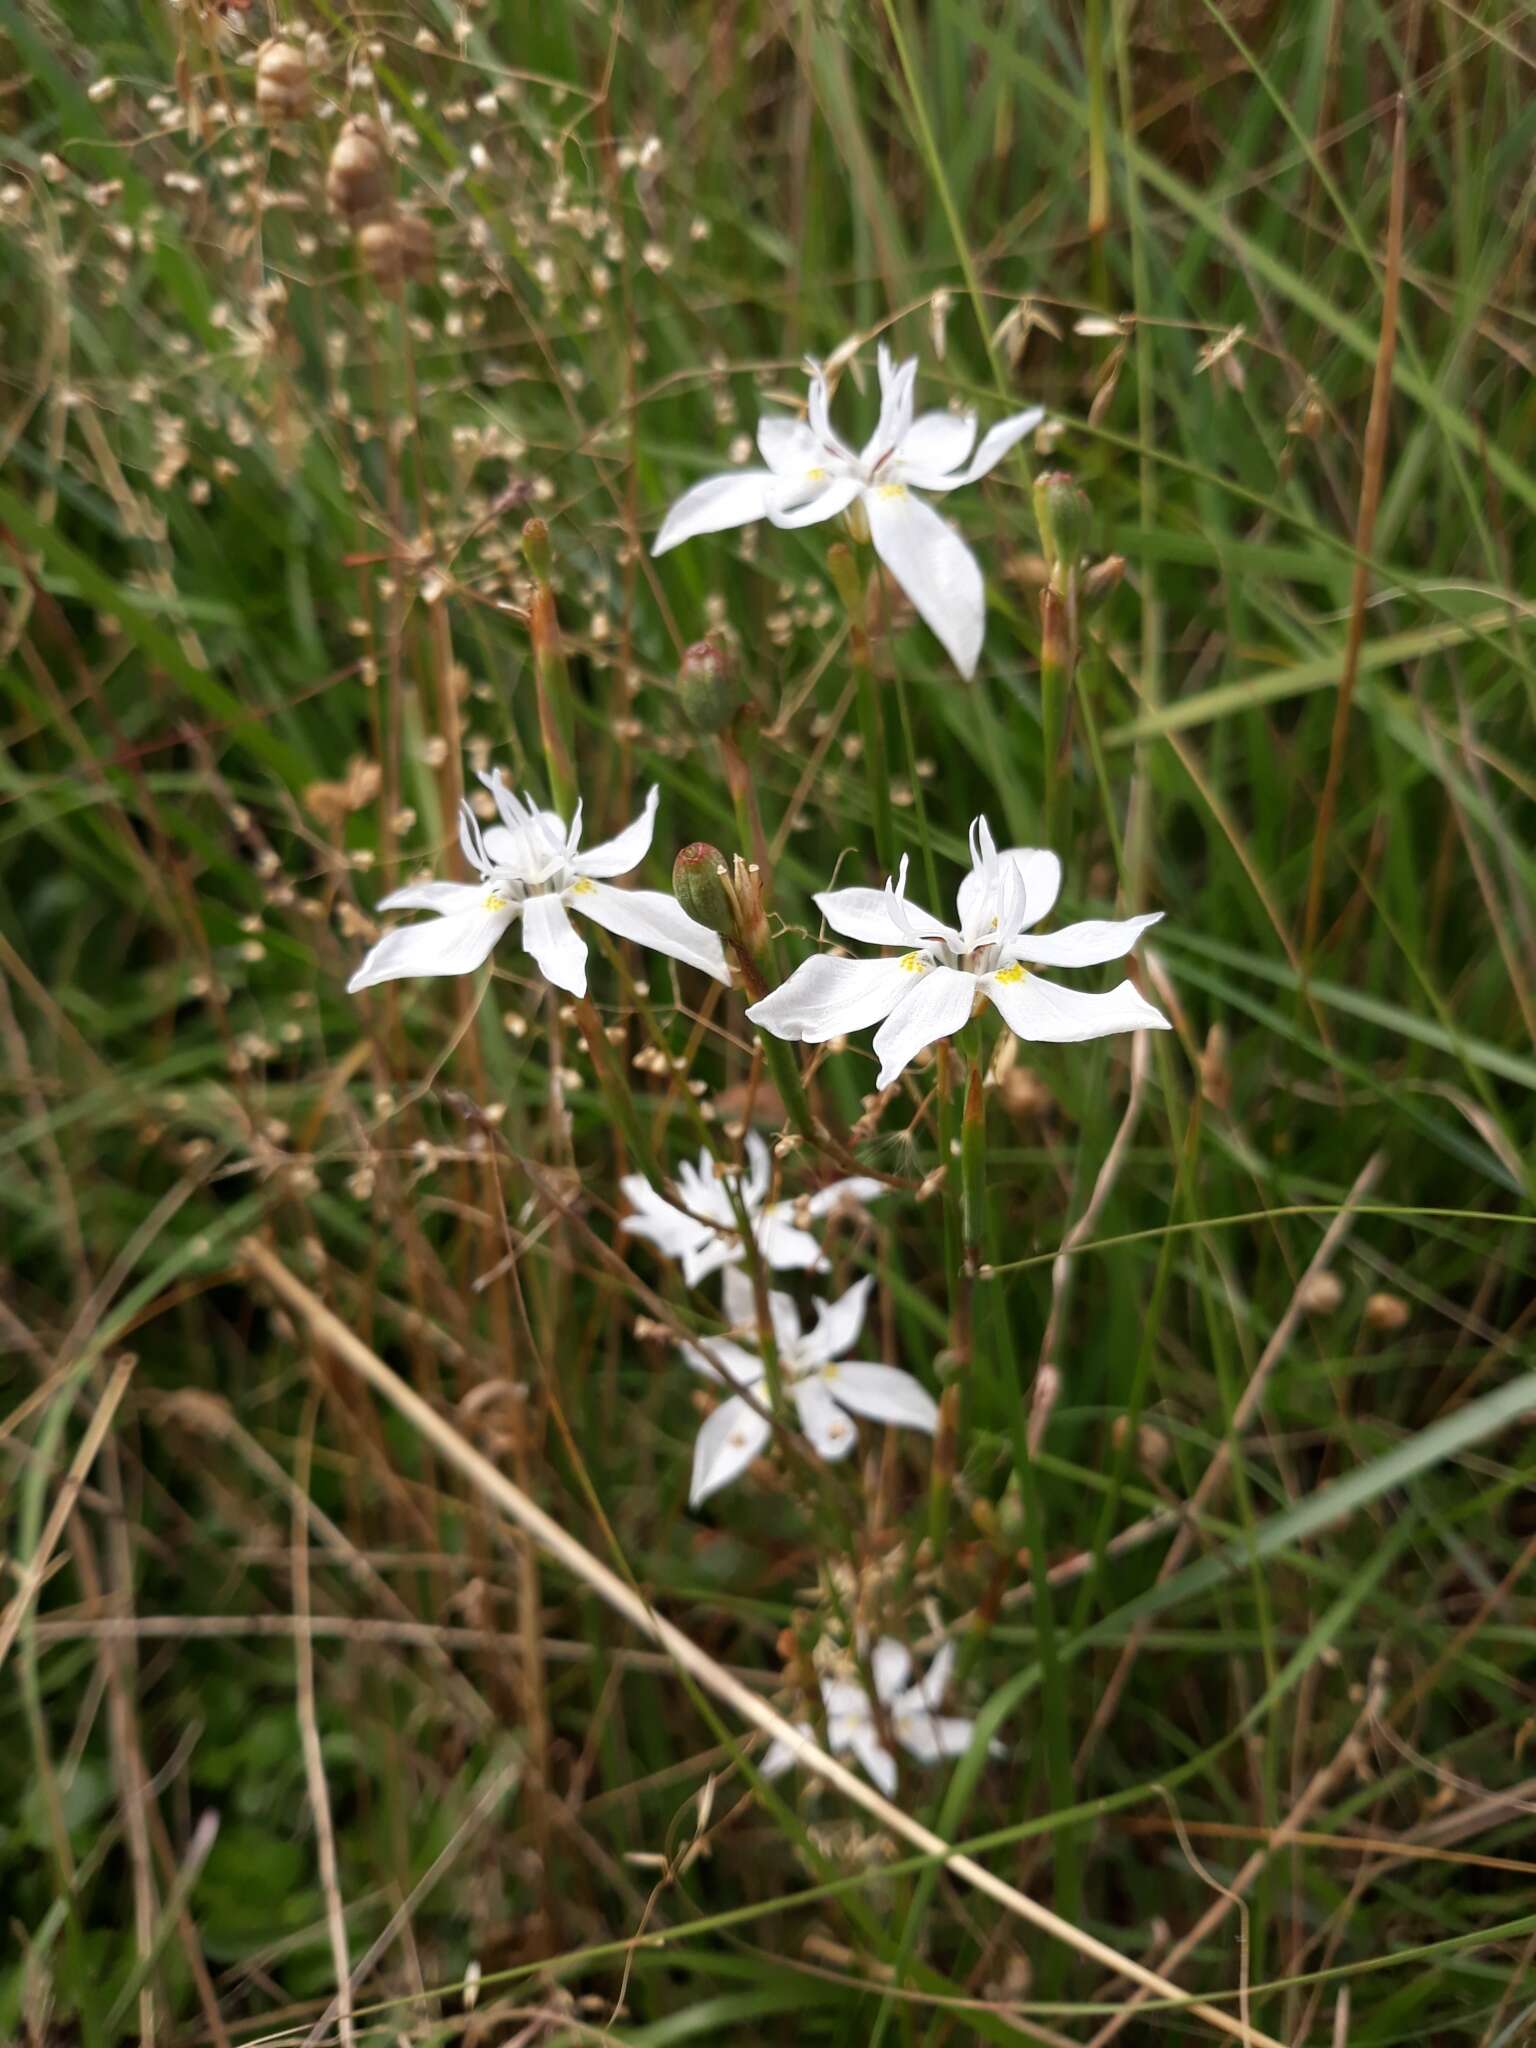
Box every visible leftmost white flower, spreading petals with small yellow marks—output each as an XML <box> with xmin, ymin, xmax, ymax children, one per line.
<box><xmin>346</xmin><ymin>774</ymin><xmax>731</xmax><ymax>995</ymax></box>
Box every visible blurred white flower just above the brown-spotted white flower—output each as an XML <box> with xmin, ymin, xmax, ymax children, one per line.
<box><xmin>618</xmin><ymin>1130</ymin><xmax>885</xmax><ymax>1286</ymax></box>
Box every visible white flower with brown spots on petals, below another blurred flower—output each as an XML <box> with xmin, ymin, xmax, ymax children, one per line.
<box><xmin>678</xmin><ymin>1270</ymin><xmax>938</xmax><ymax>1507</ymax></box>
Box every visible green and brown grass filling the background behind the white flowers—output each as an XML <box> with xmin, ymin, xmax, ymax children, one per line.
<box><xmin>0</xmin><ymin>0</ymin><xmax>1536</xmax><ymax>2048</ymax></box>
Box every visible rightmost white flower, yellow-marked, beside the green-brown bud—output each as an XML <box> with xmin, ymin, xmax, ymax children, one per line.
<box><xmin>748</xmin><ymin>817</ymin><xmax>1167</xmax><ymax>1087</ymax></box>
